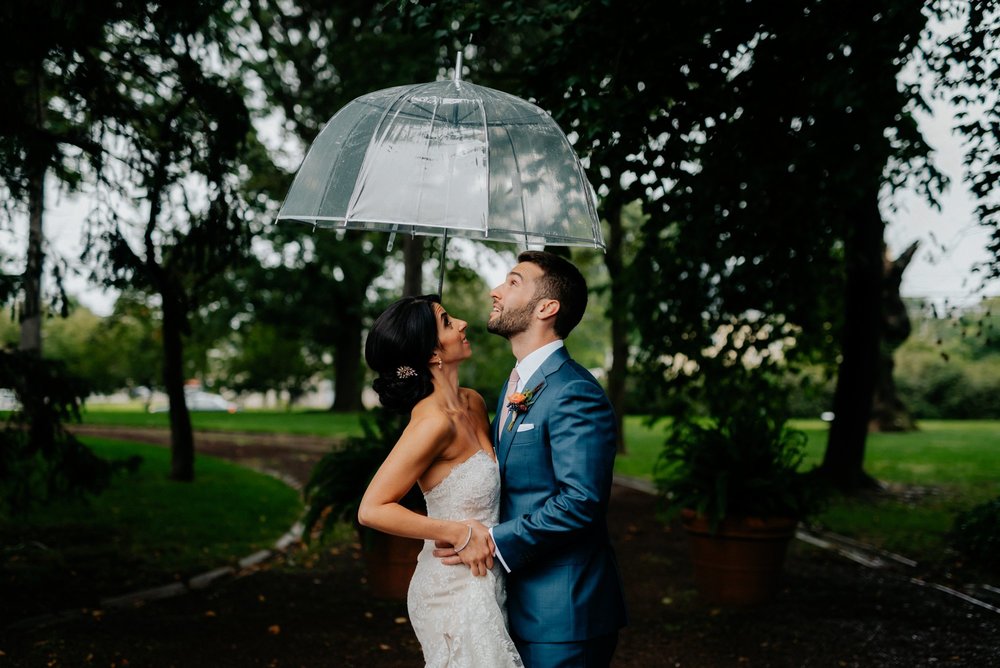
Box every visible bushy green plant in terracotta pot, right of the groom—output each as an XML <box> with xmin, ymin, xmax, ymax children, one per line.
<box><xmin>655</xmin><ymin>370</ymin><xmax>820</xmax><ymax>605</ymax></box>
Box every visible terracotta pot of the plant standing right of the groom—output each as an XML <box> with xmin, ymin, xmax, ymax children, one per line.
<box><xmin>681</xmin><ymin>510</ymin><xmax>797</xmax><ymax>606</ymax></box>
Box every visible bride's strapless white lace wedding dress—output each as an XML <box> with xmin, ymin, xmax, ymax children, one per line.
<box><xmin>407</xmin><ymin>451</ymin><xmax>524</xmax><ymax>668</ymax></box>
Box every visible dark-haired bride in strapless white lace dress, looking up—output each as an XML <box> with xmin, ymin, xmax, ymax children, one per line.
<box><xmin>358</xmin><ymin>295</ymin><xmax>523</xmax><ymax>668</ymax></box>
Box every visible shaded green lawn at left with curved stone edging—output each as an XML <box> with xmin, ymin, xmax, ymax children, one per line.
<box><xmin>0</xmin><ymin>438</ymin><xmax>302</xmax><ymax>628</ymax></box>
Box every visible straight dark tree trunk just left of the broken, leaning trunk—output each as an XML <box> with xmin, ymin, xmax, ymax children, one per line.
<box><xmin>821</xmin><ymin>201</ymin><xmax>884</xmax><ymax>490</ymax></box>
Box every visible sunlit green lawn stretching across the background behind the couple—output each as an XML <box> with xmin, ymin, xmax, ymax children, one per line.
<box><xmin>64</xmin><ymin>407</ymin><xmax>1000</xmax><ymax>576</ymax></box>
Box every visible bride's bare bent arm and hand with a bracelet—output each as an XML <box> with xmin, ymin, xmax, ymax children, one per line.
<box><xmin>358</xmin><ymin>414</ymin><xmax>493</xmax><ymax>575</ymax></box>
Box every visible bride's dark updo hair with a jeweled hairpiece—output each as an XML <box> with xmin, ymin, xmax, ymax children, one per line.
<box><xmin>365</xmin><ymin>295</ymin><xmax>441</xmax><ymax>413</ymax></box>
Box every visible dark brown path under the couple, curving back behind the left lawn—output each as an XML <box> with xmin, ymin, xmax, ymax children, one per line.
<box><xmin>0</xmin><ymin>426</ymin><xmax>1000</xmax><ymax>668</ymax></box>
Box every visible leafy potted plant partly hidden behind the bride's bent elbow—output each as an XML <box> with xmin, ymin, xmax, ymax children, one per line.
<box><xmin>303</xmin><ymin>409</ymin><xmax>426</xmax><ymax>601</ymax></box>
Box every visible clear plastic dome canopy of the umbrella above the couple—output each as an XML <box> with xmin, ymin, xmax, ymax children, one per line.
<box><xmin>278</xmin><ymin>67</ymin><xmax>604</xmax><ymax>248</ymax></box>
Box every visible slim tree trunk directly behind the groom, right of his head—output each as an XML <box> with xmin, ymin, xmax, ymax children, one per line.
<box><xmin>604</xmin><ymin>203</ymin><xmax>629</xmax><ymax>453</ymax></box>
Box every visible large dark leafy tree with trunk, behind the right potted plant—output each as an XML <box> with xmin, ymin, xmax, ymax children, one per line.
<box><xmin>584</xmin><ymin>1</ymin><xmax>936</xmax><ymax>487</ymax></box>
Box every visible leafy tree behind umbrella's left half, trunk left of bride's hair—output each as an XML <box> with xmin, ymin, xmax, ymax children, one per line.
<box><xmin>242</xmin><ymin>0</ymin><xmax>460</xmax><ymax>411</ymax></box>
